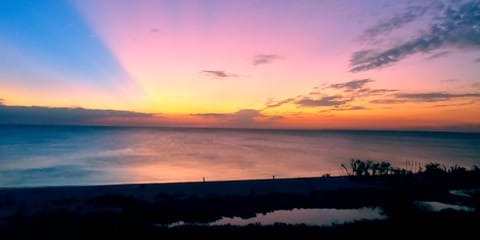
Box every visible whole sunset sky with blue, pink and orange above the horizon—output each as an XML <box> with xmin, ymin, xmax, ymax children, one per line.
<box><xmin>0</xmin><ymin>0</ymin><xmax>480</xmax><ymax>131</ymax></box>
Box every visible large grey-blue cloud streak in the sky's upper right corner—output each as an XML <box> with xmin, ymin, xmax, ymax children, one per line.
<box><xmin>350</xmin><ymin>1</ymin><xmax>480</xmax><ymax>72</ymax></box>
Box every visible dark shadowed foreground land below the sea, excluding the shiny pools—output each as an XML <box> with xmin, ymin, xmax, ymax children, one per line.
<box><xmin>0</xmin><ymin>174</ymin><xmax>480</xmax><ymax>239</ymax></box>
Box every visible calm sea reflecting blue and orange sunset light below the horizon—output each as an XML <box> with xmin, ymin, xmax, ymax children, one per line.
<box><xmin>0</xmin><ymin>126</ymin><xmax>480</xmax><ymax>187</ymax></box>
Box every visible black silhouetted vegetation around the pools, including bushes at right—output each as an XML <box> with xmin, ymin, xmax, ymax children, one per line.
<box><xmin>0</xmin><ymin>160</ymin><xmax>480</xmax><ymax>239</ymax></box>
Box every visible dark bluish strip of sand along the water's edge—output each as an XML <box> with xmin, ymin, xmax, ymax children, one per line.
<box><xmin>0</xmin><ymin>177</ymin><xmax>373</xmax><ymax>212</ymax></box>
